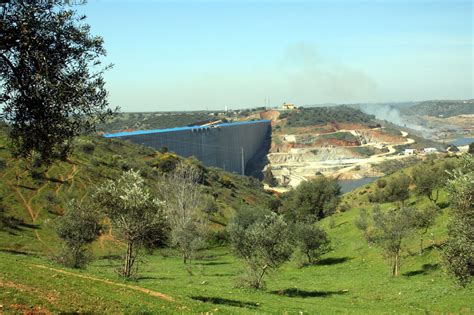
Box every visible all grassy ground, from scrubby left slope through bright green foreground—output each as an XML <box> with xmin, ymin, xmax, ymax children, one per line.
<box><xmin>0</xmin><ymin>128</ymin><xmax>474</xmax><ymax>314</ymax></box>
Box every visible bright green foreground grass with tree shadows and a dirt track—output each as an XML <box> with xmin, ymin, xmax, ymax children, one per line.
<box><xmin>0</xmin><ymin>201</ymin><xmax>474</xmax><ymax>314</ymax></box>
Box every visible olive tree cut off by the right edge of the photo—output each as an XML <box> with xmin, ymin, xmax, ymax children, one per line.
<box><xmin>444</xmin><ymin>154</ymin><xmax>474</xmax><ymax>286</ymax></box>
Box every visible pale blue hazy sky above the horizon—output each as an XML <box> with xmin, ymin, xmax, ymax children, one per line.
<box><xmin>76</xmin><ymin>0</ymin><xmax>474</xmax><ymax>111</ymax></box>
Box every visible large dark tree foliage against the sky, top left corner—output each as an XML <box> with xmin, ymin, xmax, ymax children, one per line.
<box><xmin>0</xmin><ymin>0</ymin><xmax>112</xmax><ymax>164</ymax></box>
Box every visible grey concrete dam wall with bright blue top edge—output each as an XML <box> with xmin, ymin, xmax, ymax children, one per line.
<box><xmin>104</xmin><ymin>120</ymin><xmax>272</xmax><ymax>177</ymax></box>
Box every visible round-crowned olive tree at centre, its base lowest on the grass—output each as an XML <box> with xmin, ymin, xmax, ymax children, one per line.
<box><xmin>227</xmin><ymin>208</ymin><xmax>293</xmax><ymax>289</ymax></box>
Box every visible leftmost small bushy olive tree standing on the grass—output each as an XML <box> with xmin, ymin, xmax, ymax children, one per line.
<box><xmin>56</xmin><ymin>200</ymin><xmax>101</xmax><ymax>268</ymax></box>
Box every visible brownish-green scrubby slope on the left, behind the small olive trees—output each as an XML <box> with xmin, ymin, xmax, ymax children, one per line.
<box><xmin>0</xmin><ymin>126</ymin><xmax>272</xmax><ymax>253</ymax></box>
